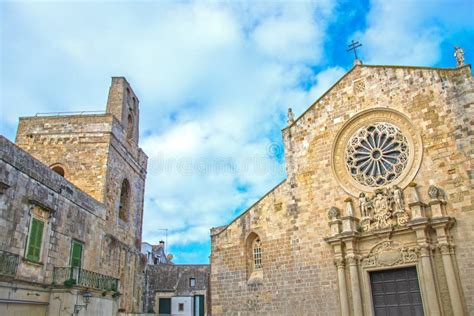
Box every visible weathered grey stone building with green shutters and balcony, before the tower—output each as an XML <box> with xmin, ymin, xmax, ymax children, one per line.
<box><xmin>0</xmin><ymin>136</ymin><xmax>118</xmax><ymax>315</ymax></box>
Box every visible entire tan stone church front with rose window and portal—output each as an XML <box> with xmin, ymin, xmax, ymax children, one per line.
<box><xmin>211</xmin><ymin>64</ymin><xmax>474</xmax><ymax>316</ymax></box>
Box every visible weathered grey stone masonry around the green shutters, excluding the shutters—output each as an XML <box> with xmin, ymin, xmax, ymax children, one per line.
<box><xmin>0</xmin><ymin>136</ymin><xmax>118</xmax><ymax>315</ymax></box>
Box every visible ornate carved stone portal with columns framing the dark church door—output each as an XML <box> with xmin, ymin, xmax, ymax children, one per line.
<box><xmin>325</xmin><ymin>183</ymin><xmax>466</xmax><ymax>315</ymax></box>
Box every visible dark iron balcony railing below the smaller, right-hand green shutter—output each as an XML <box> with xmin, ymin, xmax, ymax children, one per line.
<box><xmin>53</xmin><ymin>267</ymin><xmax>119</xmax><ymax>291</ymax></box>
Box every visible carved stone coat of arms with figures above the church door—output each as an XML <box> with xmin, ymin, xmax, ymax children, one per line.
<box><xmin>359</xmin><ymin>185</ymin><xmax>410</xmax><ymax>231</ymax></box>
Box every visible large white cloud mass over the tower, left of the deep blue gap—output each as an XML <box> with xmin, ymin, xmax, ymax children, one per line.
<box><xmin>1</xmin><ymin>1</ymin><xmax>343</xmax><ymax>257</ymax></box>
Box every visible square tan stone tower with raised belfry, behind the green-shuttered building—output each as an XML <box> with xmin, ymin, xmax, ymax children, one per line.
<box><xmin>16</xmin><ymin>77</ymin><xmax>148</xmax><ymax>311</ymax></box>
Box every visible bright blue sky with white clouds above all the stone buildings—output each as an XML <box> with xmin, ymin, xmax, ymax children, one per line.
<box><xmin>0</xmin><ymin>0</ymin><xmax>474</xmax><ymax>263</ymax></box>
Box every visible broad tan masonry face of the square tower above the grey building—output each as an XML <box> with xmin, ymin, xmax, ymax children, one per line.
<box><xmin>16</xmin><ymin>114</ymin><xmax>113</xmax><ymax>202</ymax></box>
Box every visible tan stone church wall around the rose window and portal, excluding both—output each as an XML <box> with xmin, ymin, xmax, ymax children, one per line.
<box><xmin>211</xmin><ymin>66</ymin><xmax>474</xmax><ymax>315</ymax></box>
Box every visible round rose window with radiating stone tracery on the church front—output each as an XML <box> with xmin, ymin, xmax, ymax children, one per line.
<box><xmin>345</xmin><ymin>122</ymin><xmax>410</xmax><ymax>187</ymax></box>
